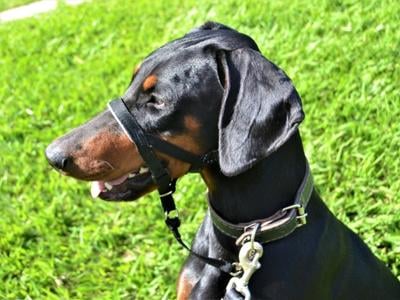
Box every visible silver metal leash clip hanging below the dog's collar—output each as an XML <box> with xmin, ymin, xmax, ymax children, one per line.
<box><xmin>226</xmin><ymin>224</ymin><xmax>263</xmax><ymax>300</ymax></box>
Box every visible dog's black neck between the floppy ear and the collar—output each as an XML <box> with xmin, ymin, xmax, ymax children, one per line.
<box><xmin>202</xmin><ymin>132</ymin><xmax>306</xmax><ymax>223</ymax></box>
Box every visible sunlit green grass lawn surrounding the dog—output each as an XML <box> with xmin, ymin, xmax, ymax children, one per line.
<box><xmin>0</xmin><ymin>0</ymin><xmax>400</xmax><ymax>299</ymax></box>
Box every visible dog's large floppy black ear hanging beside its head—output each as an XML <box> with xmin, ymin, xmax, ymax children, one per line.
<box><xmin>217</xmin><ymin>48</ymin><xmax>304</xmax><ymax>176</ymax></box>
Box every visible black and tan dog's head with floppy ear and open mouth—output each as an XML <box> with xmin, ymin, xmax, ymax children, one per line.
<box><xmin>46</xmin><ymin>22</ymin><xmax>304</xmax><ymax>200</ymax></box>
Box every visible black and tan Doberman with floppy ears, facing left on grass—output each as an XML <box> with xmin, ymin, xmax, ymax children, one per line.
<box><xmin>46</xmin><ymin>22</ymin><xmax>400</xmax><ymax>300</ymax></box>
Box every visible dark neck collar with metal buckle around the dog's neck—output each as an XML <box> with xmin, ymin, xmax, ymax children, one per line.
<box><xmin>209</xmin><ymin>162</ymin><xmax>314</xmax><ymax>245</ymax></box>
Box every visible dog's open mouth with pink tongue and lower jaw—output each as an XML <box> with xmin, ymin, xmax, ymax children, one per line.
<box><xmin>91</xmin><ymin>166</ymin><xmax>155</xmax><ymax>201</ymax></box>
